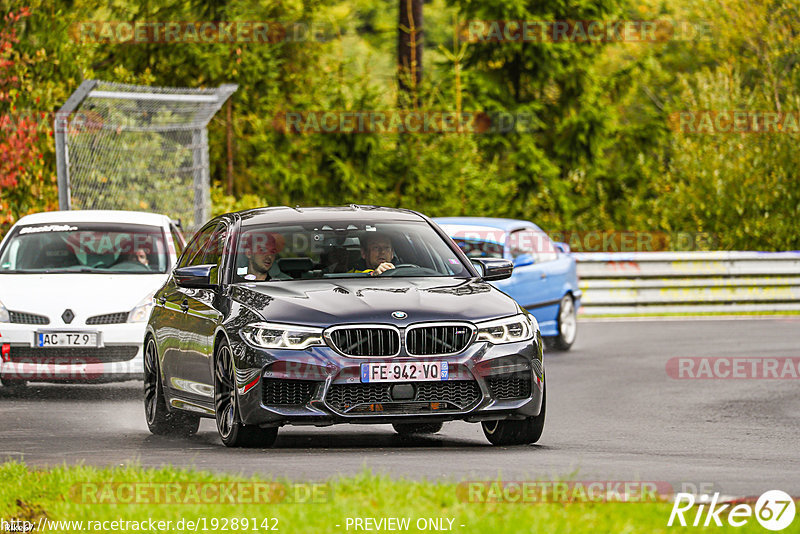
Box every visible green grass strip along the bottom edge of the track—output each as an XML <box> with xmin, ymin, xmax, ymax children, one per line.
<box><xmin>0</xmin><ymin>462</ymin><xmax>776</xmax><ymax>534</ymax></box>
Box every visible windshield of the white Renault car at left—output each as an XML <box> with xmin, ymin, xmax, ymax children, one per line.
<box><xmin>0</xmin><ymin>223</ymin><xmax>169</xmax><ymax>274</ymax></box>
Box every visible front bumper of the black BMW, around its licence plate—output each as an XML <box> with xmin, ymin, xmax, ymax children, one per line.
<box><xmin>234</xmin><ymin>334</ymin><xmax>544</xmax><ymax>426</ymax></box>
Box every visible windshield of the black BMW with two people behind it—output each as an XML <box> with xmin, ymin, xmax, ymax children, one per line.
<box><xmin>234</xmin><ymin>221</ymin><xmax>472</xmax><ymax>282</ymax></box>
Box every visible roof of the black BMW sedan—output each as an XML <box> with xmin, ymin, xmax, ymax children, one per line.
<box><xmin>237</xmin><ymin>204</ymin><xmax>425</xmax><ymax>226</ymax></box>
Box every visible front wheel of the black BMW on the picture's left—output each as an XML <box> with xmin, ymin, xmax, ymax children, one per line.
<box><xmin>214</xmin><ymin>340</ymin><xmax>278</xmax><ymax>448</ymax></box>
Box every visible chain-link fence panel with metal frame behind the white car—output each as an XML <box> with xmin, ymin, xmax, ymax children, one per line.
<box><xmin>55</xmin><ymin>80</ymin><xmax>237</xmax><ymax>229</ymax></box>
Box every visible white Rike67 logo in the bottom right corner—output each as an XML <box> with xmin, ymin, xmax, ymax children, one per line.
<box><xmin>667</xmin><ymin>490</ymin><xmax>795</xmax><ymax>531</ymax></box>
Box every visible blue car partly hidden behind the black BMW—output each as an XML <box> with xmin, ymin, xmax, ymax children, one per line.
<box><xmin>434</xmin><ymin>217</ymin><xmax>581</xmax><ymax>350</ymax></box>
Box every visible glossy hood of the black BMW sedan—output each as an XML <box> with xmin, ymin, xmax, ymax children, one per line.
<box><xmin>231</xmin><ymin>278</ymin><xmax>519</xmax><ymax>326</ymax></box>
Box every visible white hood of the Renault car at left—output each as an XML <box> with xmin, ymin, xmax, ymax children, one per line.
<box><xmin>0</xmin><ymin>273</ymin><xmax>167</xmax><ymax>326</ymax></box>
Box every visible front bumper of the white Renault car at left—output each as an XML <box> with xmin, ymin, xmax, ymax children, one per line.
<box><xmin>0</xmin><ymin>323</ymin><xmax>146</xmax><ymax>383</ymax></box>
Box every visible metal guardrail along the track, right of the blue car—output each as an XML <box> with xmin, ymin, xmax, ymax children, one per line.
<box><xmin>574</xmin><ymin>252</ymin><xmax>800</xmax><ymax>316</ymax></box>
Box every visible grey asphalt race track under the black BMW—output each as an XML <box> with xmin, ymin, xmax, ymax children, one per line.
<box><xmin>0</xmin><ymin>317</ymin><xmax>800</xmax><ymax>495</ymax></box>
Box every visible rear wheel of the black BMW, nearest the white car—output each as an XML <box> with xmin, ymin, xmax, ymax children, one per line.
<box><xmin>144</xmin><ymin>337</ymin><xmax>200</xmax><ymax>436</ymax></box>
